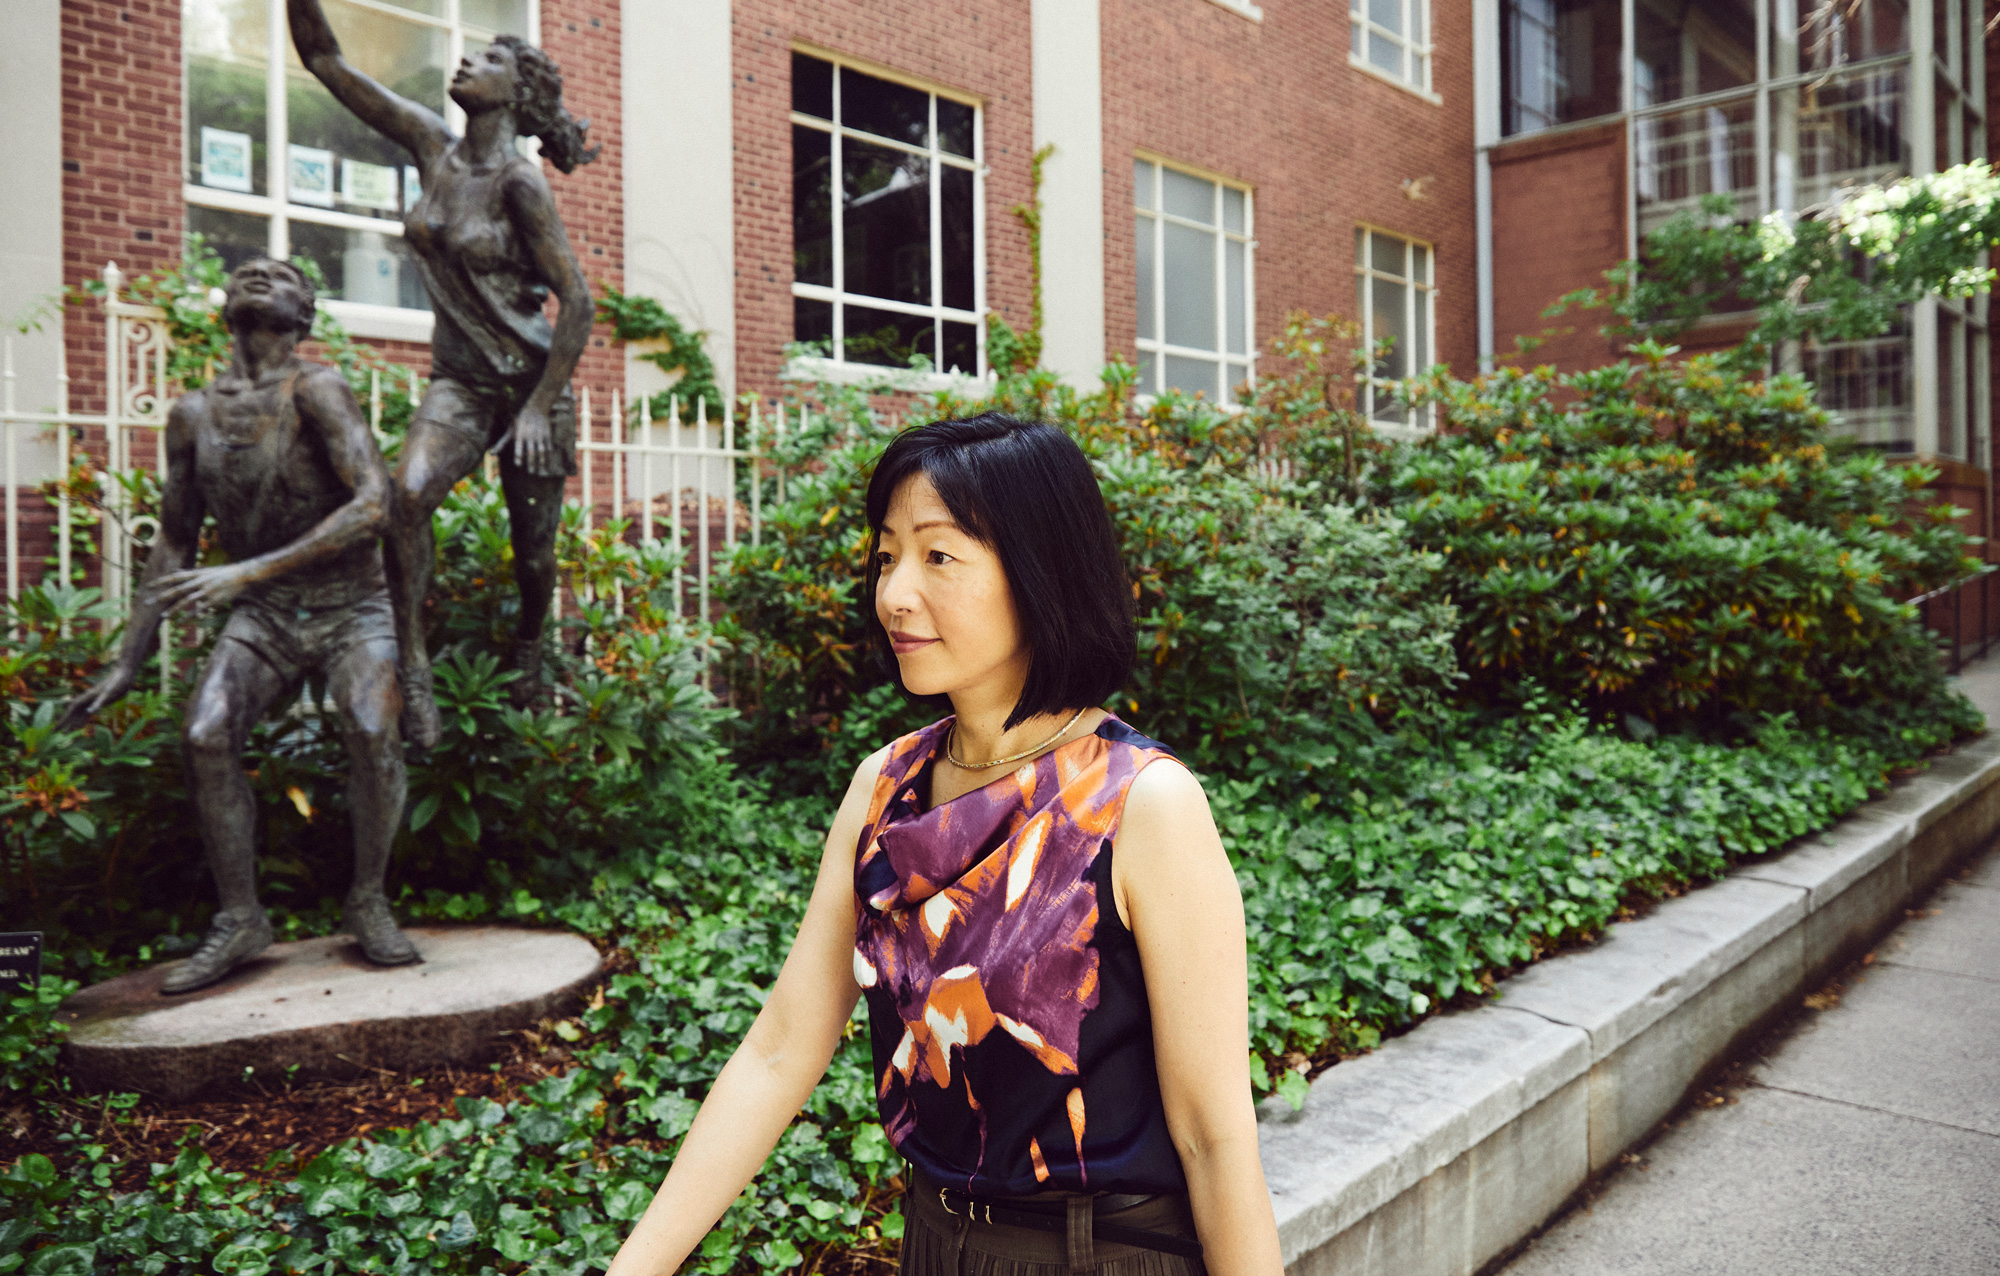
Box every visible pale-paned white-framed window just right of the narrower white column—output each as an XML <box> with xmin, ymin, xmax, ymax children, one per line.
<box><xmin>1132</xmin><ymin>156</ymin><xmax>1256</xmax><ymax>402</ymax></box>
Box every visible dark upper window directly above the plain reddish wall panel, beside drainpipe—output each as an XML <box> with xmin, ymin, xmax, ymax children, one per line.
<box><xmin>1500</xmin><ymin>0</ymin><xmax>1622</xmax><ymax>134</ymax></box>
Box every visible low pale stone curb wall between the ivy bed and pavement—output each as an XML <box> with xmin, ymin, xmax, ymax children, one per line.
<box><xmin>1258</xmin><ymin>734</ymin><xmax>2000</xmax><ymax>1276</ymax></box>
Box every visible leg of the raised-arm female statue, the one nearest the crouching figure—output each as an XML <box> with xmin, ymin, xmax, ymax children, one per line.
<box><xmin>382</xmin><ymin>378</ymin><xmax>490</xmax><ymax>748</ymax></box>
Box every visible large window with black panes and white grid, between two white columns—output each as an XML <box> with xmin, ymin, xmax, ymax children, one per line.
<box><xmin>792</xmin><ymin>52</ymin><xmax>986</xmax><ymax>376</ymax></box>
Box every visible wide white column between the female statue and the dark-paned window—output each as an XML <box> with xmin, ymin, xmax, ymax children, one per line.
<box><xmin>622</xmin><ymin>0</ymin><xmax>736</xmax><ymax>404</ymax></box>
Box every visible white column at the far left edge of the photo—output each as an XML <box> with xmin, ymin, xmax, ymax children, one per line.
<box><xmin>0</xmin><ymin>0</ymin><xmax>62</xmax><ymax>480</ymax></box>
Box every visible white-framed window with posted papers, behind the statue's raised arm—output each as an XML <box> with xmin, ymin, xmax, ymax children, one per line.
<box><xmin>180</xmin><ymin>0</ymin><xmax>538</xmax><ymax>340</ymax></box>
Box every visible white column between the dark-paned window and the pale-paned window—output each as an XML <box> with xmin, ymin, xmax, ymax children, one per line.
<box><xmin>1030</xmin><ymin>0</ymin><xmax>1106</xmax><ymax>390</ymax></box>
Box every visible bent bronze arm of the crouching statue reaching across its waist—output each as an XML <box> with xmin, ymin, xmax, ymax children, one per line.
<box><xmin>148</xmin><ymin>366</ymin><xmax>388</xmax><ymax>608</ymax></box>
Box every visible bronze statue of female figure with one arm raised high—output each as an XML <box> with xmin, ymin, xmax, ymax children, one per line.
<box><xmin>286</xmin><ymin>0</ymin><xmax>596</xmax><ymax>748</ymax></box>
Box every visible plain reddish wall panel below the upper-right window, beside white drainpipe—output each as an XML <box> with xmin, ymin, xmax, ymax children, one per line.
<box><xmin>1492</xmin><ymin>124</ymin><xmax>1626</xmax><ymax>372</ymax></box>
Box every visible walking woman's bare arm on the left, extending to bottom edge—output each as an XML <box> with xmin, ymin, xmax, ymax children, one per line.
<box><xmin>606</xmin><ymin>754</ymin><xmax>882</xmax><ymax>1276</ymax></box>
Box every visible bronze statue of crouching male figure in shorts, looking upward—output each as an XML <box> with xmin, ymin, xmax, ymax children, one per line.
<box><xmin>64</xmin><ymin>258</ymin><xmax>418</xmax><ymax>992</ymax></box>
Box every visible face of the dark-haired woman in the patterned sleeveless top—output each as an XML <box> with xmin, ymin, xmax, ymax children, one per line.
<box><xmin>874</xmin><ymin>474</ymin><xmax>1028</xmax><ymax>700</ymax></box>
